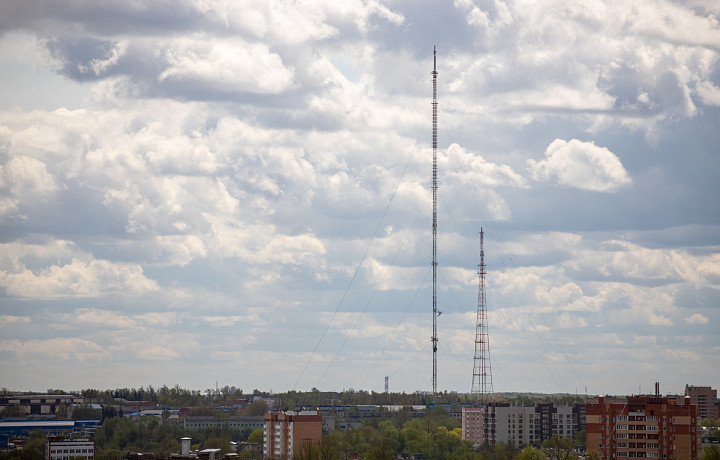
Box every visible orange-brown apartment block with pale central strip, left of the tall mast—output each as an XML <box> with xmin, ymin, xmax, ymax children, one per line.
<box><xmin>263</xmin><ymin>410</ymin><xmax>322</xmax><ymax>460</ymax></box>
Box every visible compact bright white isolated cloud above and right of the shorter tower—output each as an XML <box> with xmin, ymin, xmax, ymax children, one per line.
<box><xmin>528</xmin><ymin>139</ymin><xmax>632</xmax><ymax>193</ymax></box>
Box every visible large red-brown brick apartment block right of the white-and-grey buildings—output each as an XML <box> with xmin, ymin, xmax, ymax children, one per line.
<box><xmin>586</xmin><ymin>396</ymin><xmax>700</xmax><ymax>460</ymax></box>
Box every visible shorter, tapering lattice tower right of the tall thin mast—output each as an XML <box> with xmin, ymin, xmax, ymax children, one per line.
<box><xmin>471</xmin><ymin>227</ymin><xmax>493</xmax><ymax>404</ymax></box>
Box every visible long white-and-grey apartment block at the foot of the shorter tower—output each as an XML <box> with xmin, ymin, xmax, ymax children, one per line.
<box><xmin>461</xmin><ymin>403</ymin><xmax>585</xmax><ymax>447</ymax></box>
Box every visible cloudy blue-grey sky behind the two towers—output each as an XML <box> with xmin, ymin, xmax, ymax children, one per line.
<box><xmin>0</xmin><ymin>0</ymin><xmax>720</xmax><ymax>395</ymax></box>
